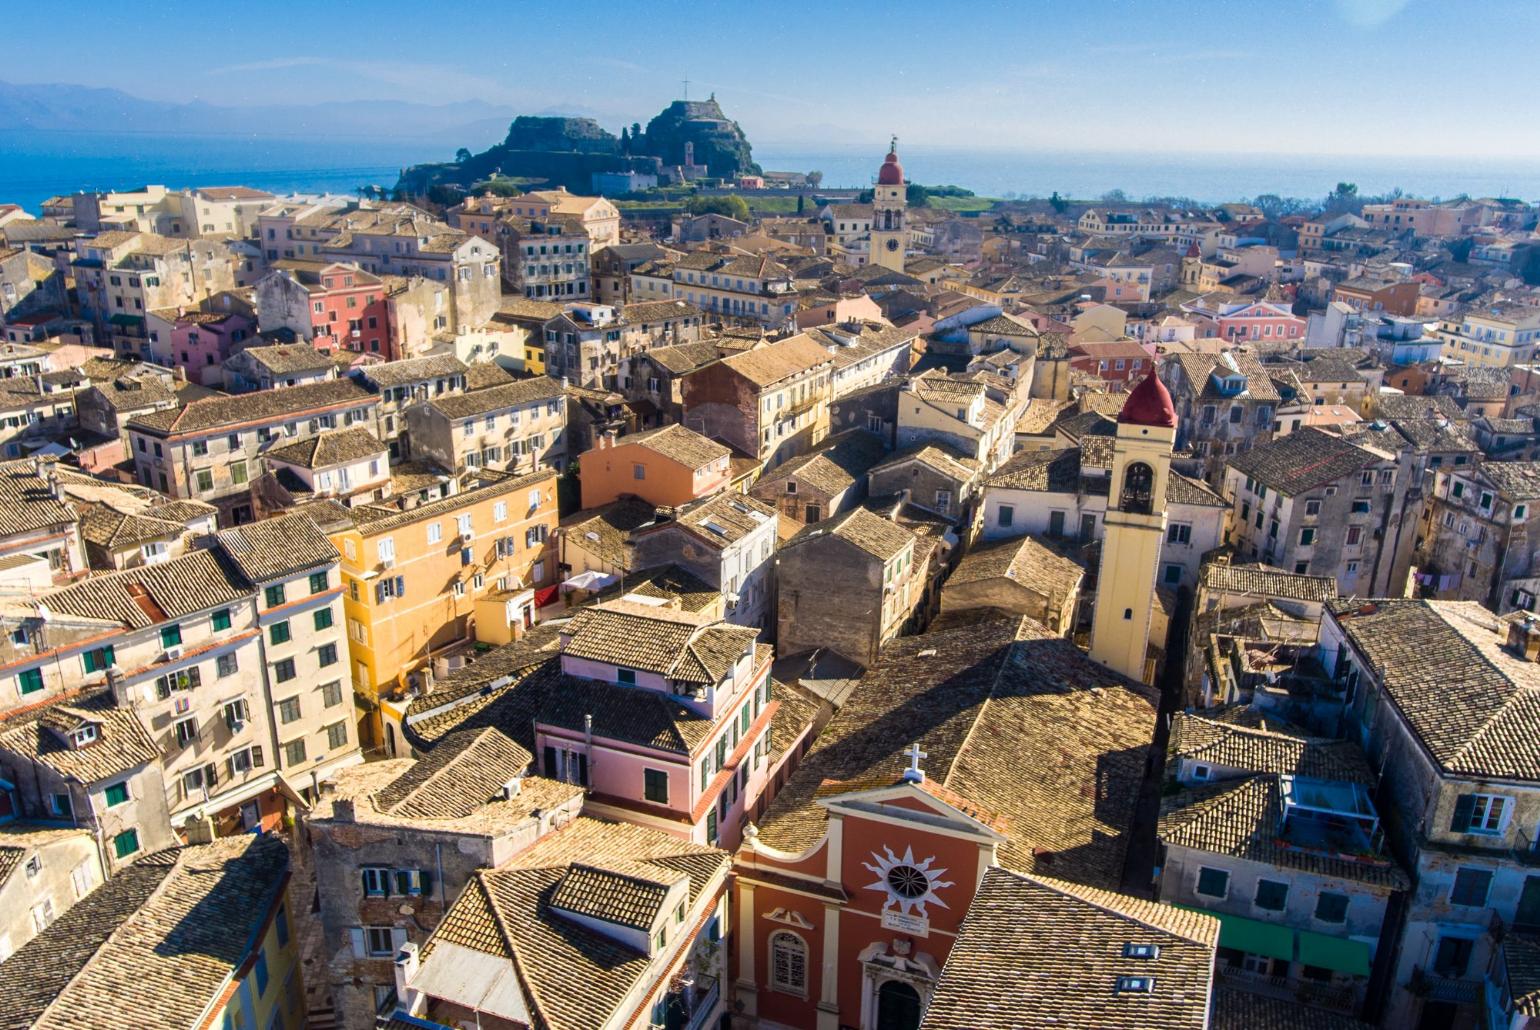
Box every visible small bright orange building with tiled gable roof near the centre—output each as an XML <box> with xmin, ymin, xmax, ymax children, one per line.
<box><xmin>579</xmin><ymin>425</ymin><xmax>732</xmax><ymax>508</ymax></box>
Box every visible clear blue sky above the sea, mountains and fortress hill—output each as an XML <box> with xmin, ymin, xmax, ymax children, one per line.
<box><xmin>3</xmin><ymin>0</ymin><xmax>1540</xmax><ymax>160</ymax></box>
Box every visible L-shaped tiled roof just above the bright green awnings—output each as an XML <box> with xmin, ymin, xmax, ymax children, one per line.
<box><xmin>1155</xmin><ymin>773</ymin><xmax>1411</xmax><ymax>890</ymax></box>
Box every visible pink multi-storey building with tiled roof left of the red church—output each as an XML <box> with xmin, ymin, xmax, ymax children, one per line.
<box><xmin>534</xmin><ymin>600</ymin><xmax>779</xmax><ymax>850</ymax></box>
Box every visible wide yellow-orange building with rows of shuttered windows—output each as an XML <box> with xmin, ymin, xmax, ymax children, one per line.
<box><xmin>330</xmin><ymin>470</ymin><xmax>557</xmax><ymax>714</ymax></box>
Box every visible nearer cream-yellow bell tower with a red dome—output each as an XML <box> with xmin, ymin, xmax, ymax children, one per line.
<box><xmin>1090</xmin><ymin>373</ymin><xmax>1177</xmax><ymax>682</ymax></box>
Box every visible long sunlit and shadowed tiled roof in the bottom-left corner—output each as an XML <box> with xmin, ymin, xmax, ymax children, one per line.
<box><xmin>0</xmin><ymin>834</ymin><xmax>288</xmax><ymax>1030</ymax></box>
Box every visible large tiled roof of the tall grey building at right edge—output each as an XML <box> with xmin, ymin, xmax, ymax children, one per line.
<box><xmin>1329</xmin><ymin>599</ymin><xmax>1540</xmax><ymax>781</ymax></box>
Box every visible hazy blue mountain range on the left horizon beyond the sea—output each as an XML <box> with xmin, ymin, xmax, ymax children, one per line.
<box><xmin>0</xmin><ymin>82</ymin><xmax>514</xmax><ymax>143</ymax></box>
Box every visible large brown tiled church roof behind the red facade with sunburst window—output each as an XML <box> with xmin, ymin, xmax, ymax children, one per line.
<box><xmin>759</xmin><ymin>617</ymin><xmax>1155</xmax><ymax>887</ymax></box>
